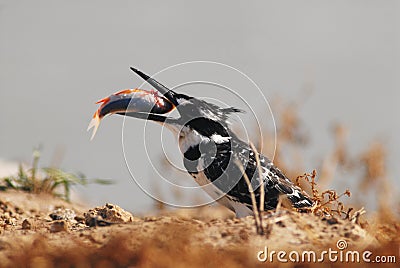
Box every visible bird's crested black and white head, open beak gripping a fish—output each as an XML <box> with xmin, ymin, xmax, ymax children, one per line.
<box><xmin>89</xmin><ymin>67</ymin><xmax>241</xmax><ymax>138</ymax></box>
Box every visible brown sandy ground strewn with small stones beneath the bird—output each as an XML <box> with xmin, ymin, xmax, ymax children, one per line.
<box><xmin>0</xmin><ymin>191</ymin><xmax>400</xmax><ymax>267</ymax></box>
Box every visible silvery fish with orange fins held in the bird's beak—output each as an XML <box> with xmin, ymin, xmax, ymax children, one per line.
<box><xmin>87</xmin><ymin>89</ymin><xmax>175</xmax><ymax>140</ymax></box>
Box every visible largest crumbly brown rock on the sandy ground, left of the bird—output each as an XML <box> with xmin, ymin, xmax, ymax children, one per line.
<box><xmin>84</xmin><ymin>203</ymin><xmax>134</xmax><ymax>226</ymax></box>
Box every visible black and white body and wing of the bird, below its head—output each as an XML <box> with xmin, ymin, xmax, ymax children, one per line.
<box><xmin>179</xmin><ymin>117</ymin><xmax>313</xmax><ymax>217</ymax></box>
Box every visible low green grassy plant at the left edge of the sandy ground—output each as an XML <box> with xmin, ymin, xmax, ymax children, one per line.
<box><xmin>0</xmin><ymin>149</ymin><xmax>113</xmax><ymax>201</ymax></box>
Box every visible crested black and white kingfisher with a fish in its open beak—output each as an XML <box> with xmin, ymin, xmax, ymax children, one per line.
<box><xmin>89</xmin><ymin>67</ymin><xmax>313</xmax><ymax>218</ymax></box>
